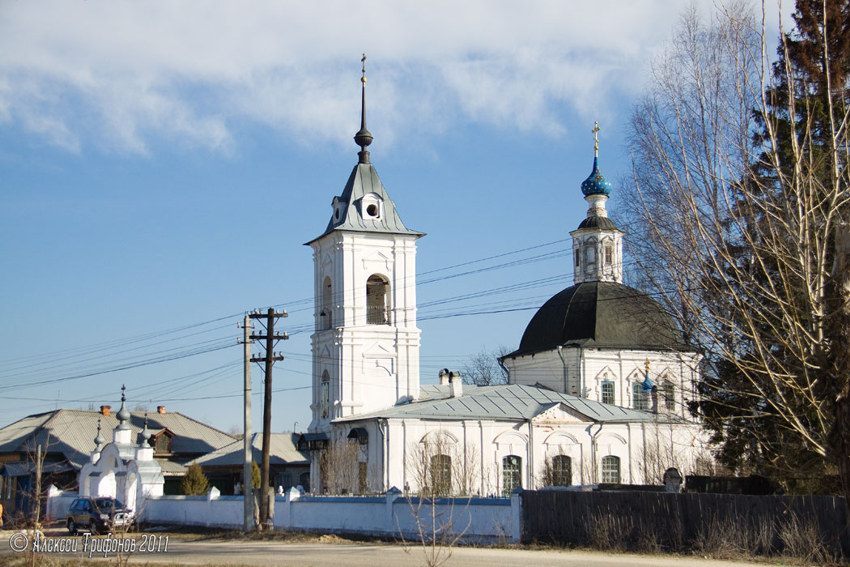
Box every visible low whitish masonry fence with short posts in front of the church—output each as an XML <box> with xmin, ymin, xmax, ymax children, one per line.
<box><xmin>47</xmin><ymin>487</ymin><xmax>521</xmax><ymax>543</ymax></box>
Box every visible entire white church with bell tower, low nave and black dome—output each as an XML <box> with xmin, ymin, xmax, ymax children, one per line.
<box><xmin>301</xmin><ymin>64</ymin><xmax>711</xmax><ymax>495</ymax></box>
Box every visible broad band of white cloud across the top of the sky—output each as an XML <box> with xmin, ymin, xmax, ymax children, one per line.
<box><xmin>0</xmin><ymin>0</ymin><xmax>780</xmax><ymax>154</ymax></box>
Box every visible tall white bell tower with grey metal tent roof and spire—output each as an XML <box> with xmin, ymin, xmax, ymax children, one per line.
<box><xmin>307</xmin><ymin>55</ymin><xmax>424</xmax><ymax>432</ymax></box>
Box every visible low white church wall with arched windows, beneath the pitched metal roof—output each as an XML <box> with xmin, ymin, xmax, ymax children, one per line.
<box><xmin>369</xmin><ymin>415</ymin><xmax>710</xmax><ymax>495</ymax></box>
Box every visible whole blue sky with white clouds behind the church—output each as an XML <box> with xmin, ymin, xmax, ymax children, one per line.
<box><xmin>0</xmin><ymin>0</ymin><xmax>780</xmax><ymax>431</ymax></box>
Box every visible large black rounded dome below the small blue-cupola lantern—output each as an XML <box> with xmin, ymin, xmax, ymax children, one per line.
<box><xmin>508</xmin><ymin>282</ymin><xmax>686</xmax><ymax>356</ymax></box>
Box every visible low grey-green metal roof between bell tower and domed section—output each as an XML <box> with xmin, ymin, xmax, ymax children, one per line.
<box><xmin>336</xmin><ymin>384</ymin><xmax>683</xmax><ymax>423</ymax></box>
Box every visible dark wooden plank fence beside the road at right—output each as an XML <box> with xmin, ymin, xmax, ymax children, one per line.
<box><xmin>522</xmin><ymin>489</ymin><xmax>850</xmax><ymax>558</ymax></box>
